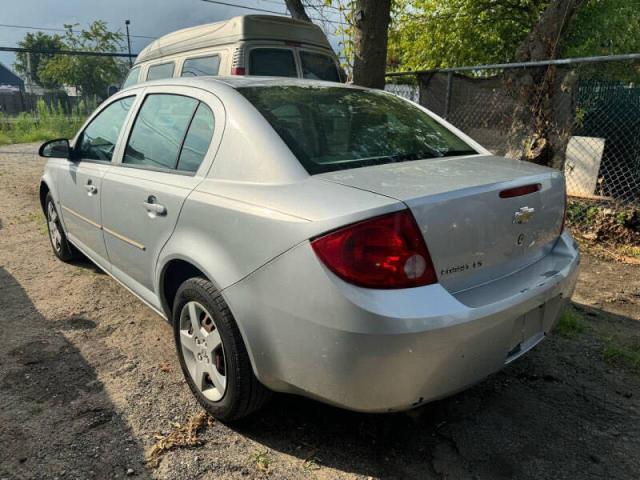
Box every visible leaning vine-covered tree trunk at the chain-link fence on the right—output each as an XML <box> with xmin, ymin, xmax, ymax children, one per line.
<box><xmin>507</xmin><ymin>0</ymin><xmax>584</xmax><ymax>168</ymax></box>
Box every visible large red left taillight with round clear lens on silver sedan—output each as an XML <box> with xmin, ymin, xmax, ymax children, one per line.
<box><xmin>311</xmin><ymin>210</ymin><xmax>438</xmax><ymax>288</ymax></box>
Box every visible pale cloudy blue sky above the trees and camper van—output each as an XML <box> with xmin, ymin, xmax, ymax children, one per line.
<box><xmin>0</xmin><ymin>0</ymin><xmax>339</xmax><ymax>72</ymax></box>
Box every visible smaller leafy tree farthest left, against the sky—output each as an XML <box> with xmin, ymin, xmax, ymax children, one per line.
<box><xmin>13</xmin><ymin>32</ymin><xmax>62</xmax><ymax>88</ymax></box>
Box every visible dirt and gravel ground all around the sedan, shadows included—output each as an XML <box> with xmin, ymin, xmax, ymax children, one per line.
<box><xmin>0</xmin><ymin>145</ymin><xmax>640</xmax><ymax>479</ymax></box>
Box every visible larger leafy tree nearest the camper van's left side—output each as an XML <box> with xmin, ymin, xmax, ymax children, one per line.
<box><xmin>40</xmin><ymin>20</ymin><xmax>126</xmax><ymax>97</ymax></box>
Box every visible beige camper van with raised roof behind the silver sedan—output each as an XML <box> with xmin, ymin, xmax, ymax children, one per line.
<box><xmin>122</xmin><ymin>15</ymin><xmax>343</xmax><ymax>88</ymax></box>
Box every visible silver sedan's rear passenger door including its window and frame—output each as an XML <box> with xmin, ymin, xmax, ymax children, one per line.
<box><xmin>102</xmin><ymin>87</ymin><xmax>224</xmax><ymax>307</ymax></box>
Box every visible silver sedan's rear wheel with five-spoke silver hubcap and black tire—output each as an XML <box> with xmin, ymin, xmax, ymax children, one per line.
<box><xmin>172</xmin><ymin>278</ymin><xmax>270</xmax><ymax>422</ymax></box>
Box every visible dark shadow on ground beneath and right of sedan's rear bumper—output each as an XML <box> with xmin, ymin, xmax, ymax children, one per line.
<box><xmin>236</xmin><ymin>306</ymin><xmax>640</xmax><ymax>479</ymax></box>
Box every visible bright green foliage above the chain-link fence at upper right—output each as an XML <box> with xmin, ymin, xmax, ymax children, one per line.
<box><xmin>388</xmin><ymin>0</ymin><xmax>640</xmax><ymax>72</ymax></box>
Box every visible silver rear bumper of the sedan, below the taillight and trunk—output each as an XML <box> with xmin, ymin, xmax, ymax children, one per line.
<box><xmin>223</xmin><ymin>232</ymin><xmax>579</xmax><ymax>412</ymax></box>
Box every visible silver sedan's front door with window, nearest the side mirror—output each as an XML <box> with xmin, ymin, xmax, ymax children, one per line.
<box><xmin>57</xmin><ymin>95</ymin><xmax>135</xmax><ymax>269</ymax></box>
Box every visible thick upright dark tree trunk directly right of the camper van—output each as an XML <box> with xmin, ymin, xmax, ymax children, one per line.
<box><xmin>353</xmin><ymin>0</ymin><xmax>391</xmax><ymax>88</ymax></box>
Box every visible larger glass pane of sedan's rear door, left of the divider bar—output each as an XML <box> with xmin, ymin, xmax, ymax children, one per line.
<box><xmin>123</xmin><ymin>94</ymin><xmax>198</xmax><ymax>169</ymax></box>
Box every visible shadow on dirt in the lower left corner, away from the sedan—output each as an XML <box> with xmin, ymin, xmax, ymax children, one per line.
<box><xmin>0</xmin><ymin>267</ymin><xmax>146</xmax><ymax>479</ymax></box>
